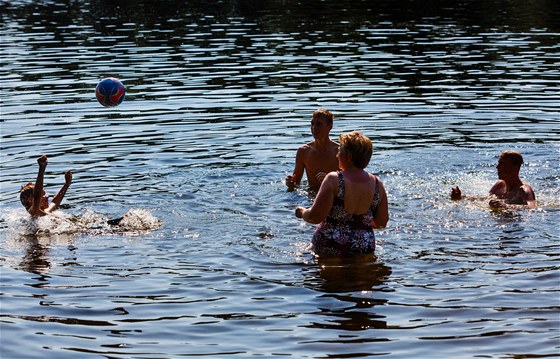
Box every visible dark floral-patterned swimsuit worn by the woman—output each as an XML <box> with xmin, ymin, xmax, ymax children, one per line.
<box><xmin>312</xmin><ymin>171</ymin><xmax>381</xmax><ymax>255</ymax></box>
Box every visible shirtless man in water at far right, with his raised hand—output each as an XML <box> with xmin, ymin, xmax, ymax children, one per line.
<box><xmin>451</xmin><ymin>150</ymin><xmax>536</xmax><ymax>209</ymax></box>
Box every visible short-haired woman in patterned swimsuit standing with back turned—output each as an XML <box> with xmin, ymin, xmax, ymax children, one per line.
<box><xmin>296</xmin><ymin>131</ymin><xmax>389</xmax><ymax>255</ymax></box>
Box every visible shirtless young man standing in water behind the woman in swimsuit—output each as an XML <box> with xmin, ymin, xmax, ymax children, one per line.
<box><xmin>286</xmin><ymin>108</ymin><xmax>338</xmax><ymax>191</ymax></box>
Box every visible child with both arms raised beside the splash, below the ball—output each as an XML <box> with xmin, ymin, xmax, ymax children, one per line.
<box><xmin>19</xmin><ymin>155</ymin><xmax>72</xmax><ymax>216</ymax></box>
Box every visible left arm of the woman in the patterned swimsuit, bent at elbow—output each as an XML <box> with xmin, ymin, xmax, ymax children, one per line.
<box><xmin>296</xmin><ymin>172</ymin><xmax>338</xmax><ymax>224</ymax></box>
